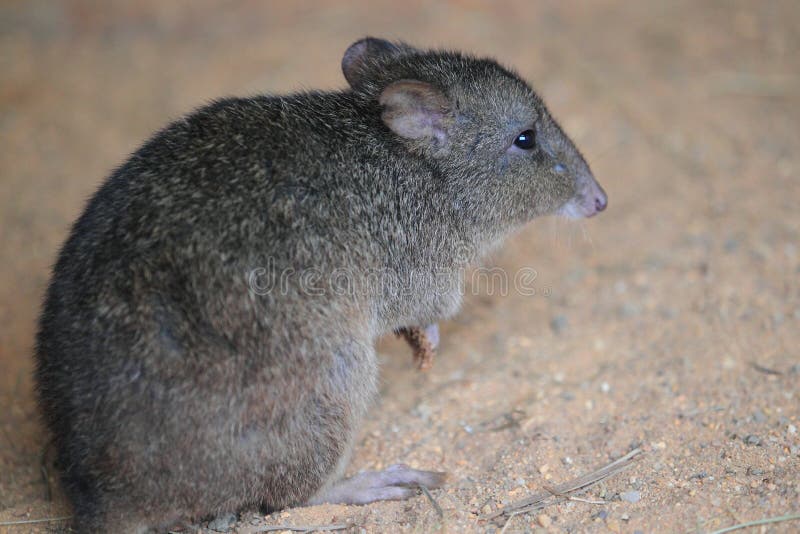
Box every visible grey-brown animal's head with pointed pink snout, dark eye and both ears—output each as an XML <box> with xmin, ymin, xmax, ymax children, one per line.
<box><xmin>342</xmin><ymin>38</ymin><xmax>607</xmax><ymax>242</ymax></box>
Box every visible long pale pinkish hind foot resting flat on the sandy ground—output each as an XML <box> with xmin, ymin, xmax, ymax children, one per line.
<box><xmin>308</xmin><ymin>464</ymin><xmax>447</xmax><ymax>505</ymax></box>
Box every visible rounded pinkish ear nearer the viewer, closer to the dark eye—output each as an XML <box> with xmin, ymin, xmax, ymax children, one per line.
<box><xmin>378</xmin><ymin>80</ymin><xmax>450</xmax><ymax>144</ymax></box>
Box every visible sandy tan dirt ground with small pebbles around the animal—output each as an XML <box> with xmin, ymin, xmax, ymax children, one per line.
<box><xmin>0</xmin><ymin>0</ymin><xmax>800</xmax><ymax>533</ymax></box>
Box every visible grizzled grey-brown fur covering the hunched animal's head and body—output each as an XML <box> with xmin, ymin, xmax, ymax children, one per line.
<box><xmin>36</xmin><ymin>39</ymin><xmax>605</xmax><ymax>532</ymax></box>
